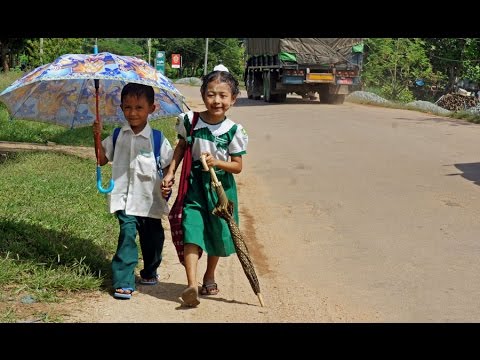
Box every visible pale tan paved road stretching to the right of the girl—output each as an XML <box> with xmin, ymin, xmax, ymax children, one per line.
<box><xmin>177</xmin><ymin>83</ymin><xmax>480</xmax><ymax>322</ymax></box>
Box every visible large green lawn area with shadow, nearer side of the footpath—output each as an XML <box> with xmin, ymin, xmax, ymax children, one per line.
<box><xmin>0</xmin><ymin>152</ymin><xmax>118</xmax><ymax>321</ymax></box>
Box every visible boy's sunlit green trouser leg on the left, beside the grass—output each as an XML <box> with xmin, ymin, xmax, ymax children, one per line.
<box><xmin>112</xmin><ymin>211</ymin><xmax>138</xmax><ymax>289</ymax></box>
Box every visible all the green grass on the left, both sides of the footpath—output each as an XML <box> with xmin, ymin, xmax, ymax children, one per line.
<box><xmin>0</xmin><ymin>74</ymin><xmax>180</xmax><ymax>322</ymax></box>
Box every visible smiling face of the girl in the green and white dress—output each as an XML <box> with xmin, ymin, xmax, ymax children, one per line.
<box><xmin>203</xmin><ymin>80</ymin><xmax>236</xmax><ymax>121</ymax></box>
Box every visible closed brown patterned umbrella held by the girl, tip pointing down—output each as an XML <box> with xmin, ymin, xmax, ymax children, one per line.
<box><xmin>200</xmin><ymin>155</ymin><xmax>265</xmax><ymax>307</ymax></box>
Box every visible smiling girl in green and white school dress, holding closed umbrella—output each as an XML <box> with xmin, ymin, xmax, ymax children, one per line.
<box><xmin>163</xmin><ymin>71</ymin><xmax>248</xmax><ymax>307</ymax></box>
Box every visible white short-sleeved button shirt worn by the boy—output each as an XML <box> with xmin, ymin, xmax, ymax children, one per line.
<box><xmin>102</xmin><ymin>123</ymin><xmax>173</xmax><ymax>219</ymax></box>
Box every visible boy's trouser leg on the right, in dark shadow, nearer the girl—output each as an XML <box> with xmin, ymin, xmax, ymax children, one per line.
<box><xmin>139</xmin><ymin>217</ymin><xmax>165</xmax><ymax>279</ymax></box>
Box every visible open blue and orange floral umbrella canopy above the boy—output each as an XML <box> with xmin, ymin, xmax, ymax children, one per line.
<box><xmin>0</xmin><ymin>52</ymin><xmax>184</xmax><ymax>128</ymax></box>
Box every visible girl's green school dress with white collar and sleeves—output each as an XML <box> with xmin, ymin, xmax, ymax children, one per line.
<box><xmin>176</xmin><ymin>111</ymin><xmax>248</xmax><ymax>256</ymax></box>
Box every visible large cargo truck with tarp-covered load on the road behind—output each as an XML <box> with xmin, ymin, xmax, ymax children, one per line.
<box><xmin>244</xmin><ymin>38</ymin><xmax>363</xmax><ymax>104</ymax></box>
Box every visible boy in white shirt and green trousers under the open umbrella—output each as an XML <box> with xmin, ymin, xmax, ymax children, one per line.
<box><xmin>93</xmin><ymin>83</ymin><xmax>173</xmax><ymax>299</ymax></box>
